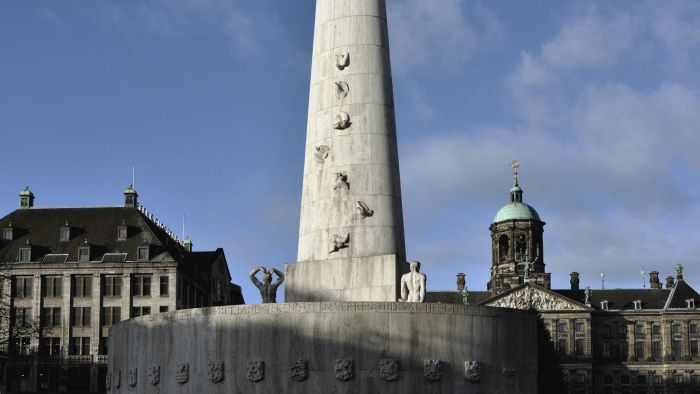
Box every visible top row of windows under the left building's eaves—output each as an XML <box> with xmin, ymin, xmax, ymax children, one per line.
<box><xmin>12</xmin><ymin>274</ymin><xmax>170</xmax><ymax>298</ymax></box>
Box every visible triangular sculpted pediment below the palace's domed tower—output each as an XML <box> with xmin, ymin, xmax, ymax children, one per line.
<box><xmin>481</xmin><ymin>283</ymin><xmax>590</xmax><ymax>311</ymax></box>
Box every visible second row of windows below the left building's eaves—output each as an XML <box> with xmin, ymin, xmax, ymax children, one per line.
<box><xmin>12</xmin><ymin>305</ymin><xmax>168</xmax><ymax>328</ymax></box>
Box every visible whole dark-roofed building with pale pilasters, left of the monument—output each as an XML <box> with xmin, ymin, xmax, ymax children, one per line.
<box><xmin>0</xmin><ymin>187</ymin><xmax>243</xmax><ymax>392</ymax></box>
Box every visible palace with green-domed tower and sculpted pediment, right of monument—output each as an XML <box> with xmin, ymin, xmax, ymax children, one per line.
<box><xmin>426</xmin><ymin>173</ymin><xmax>700</xmax><ymax>394</ymax></box>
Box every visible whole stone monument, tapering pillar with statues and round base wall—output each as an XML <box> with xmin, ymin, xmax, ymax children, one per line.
<box><xmin>106</xmin><ymin>0</ymin><xmax>537</xmax><ymax>394</ymax></box>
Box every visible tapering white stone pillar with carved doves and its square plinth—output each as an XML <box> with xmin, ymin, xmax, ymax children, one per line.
<box><xmin>285</xmin><ymin>0</ymin><xmax>408</xmax><ymax>302</ymax></box>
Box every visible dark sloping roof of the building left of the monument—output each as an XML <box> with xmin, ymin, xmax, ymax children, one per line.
<box><xmin>0</xmin><ymin>207</ymin><xmax>185</xmax><ymax>262</ymax></box>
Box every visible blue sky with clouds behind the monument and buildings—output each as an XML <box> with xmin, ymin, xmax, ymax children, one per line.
<box><xmin>0</xmin><ymin>0</ymin><xmax>700</xmax><ymax>302</ymax></box>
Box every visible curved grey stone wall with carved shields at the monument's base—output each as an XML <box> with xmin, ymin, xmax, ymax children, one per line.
<box><xmin>107</xmin><ymin>302</ymin><xmax>537</xmax><ymax>394</ymax></box>
